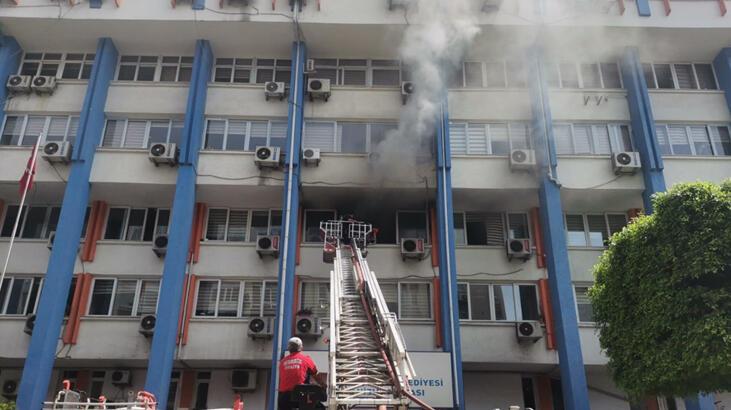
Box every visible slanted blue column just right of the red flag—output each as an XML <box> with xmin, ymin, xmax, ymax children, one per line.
<box><xmin>18</xmin><ymin>38</ymin><xmax>117</xmax><ymax>409</ymax></box>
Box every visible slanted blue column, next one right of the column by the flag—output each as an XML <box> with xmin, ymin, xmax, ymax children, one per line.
<box><xmin>145</xmin><ymin>40</ymin><xmax>213</xmax><ymax>409</ymax></box>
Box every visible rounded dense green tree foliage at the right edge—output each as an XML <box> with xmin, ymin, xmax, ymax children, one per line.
<box><xmin>589</xmin><ymin>180</ymin><xmax>731</xmax><ymax>398</ymax></box>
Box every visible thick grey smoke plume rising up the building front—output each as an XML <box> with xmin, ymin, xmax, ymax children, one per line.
<box><xmin>374</xmin><ymin>0</ymin><xmax>479</xmax><ymax>182</ymax></box>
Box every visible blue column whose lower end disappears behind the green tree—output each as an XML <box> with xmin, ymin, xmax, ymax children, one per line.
<box><xmin>622</xmin><ymin>47</ymin><xmax>665</xmax><ymax>214</ymax></box>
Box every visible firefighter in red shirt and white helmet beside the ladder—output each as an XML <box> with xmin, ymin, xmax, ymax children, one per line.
<box><xmin>277</xmin><ymin>337</ymin><xmax>325</xmax><ymax>410</ymax></box>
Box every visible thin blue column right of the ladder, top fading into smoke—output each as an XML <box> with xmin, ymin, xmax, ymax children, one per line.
<box><xmin>433</xmin><ymin>100</ymin><xmax>465</xmax><ymax>409</ymax></box>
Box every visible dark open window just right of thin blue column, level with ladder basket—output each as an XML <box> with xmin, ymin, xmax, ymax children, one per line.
<box><xmin>454</xmin><ymin>212</ymin><xmax>530</xmax><ymax>246</ymax></box>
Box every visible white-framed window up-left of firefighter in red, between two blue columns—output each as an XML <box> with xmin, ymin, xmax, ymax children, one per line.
<box><xmin>195</xmin><ymin>279</ymin><xmax>277</xmax><ymax>317</ymax></box>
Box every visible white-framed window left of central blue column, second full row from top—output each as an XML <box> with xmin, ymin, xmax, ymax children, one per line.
<box><xmin>204</xmin><ymin>119</ymin><xmax>287</xmax><ymax>151</ymax></box>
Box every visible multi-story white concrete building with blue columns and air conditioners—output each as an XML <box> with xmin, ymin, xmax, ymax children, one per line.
<box><xmin>0</xmin><ymin>0</ymin><xmax>731</xmax><ymax>410</ymax></box>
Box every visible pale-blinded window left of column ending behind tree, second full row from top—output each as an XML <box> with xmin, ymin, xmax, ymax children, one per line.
<box><xmin>553</xmin><ymin>124</ymin><xmax>633</xmax><ymax>155</ymax></box>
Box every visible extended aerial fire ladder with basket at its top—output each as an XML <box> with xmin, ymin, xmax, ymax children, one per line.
<box><xmin>320</xmin><ymin>220</ymin><xmax>432</xmax><ymax>410</ymax></box>
